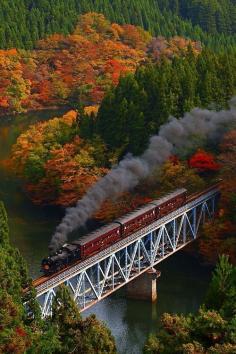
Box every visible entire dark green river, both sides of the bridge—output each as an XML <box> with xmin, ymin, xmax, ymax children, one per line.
<box><xmin>0</xmin><ymin>111</ymin><xmax>213</xmax><ymax>354</ymax></box>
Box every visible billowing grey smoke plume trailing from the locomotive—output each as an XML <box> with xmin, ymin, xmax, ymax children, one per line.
<box><xmin>49</xmin><ymin>98</ymin><xmax>236</xmax><ymax>252</ymax></box>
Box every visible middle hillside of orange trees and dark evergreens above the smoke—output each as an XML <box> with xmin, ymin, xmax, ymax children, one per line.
<box><xmin>12</xmin><ymin>46</ymin><xmax>236</xmax><ymax>210</ymax></box>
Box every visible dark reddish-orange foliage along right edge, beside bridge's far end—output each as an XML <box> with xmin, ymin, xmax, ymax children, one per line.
<box><xmin>199</xmin><ymin>130</ymin><xmax>236</xmax><ymax>263</ymax></box>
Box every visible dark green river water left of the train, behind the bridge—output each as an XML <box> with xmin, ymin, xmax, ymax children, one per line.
<box><xmin>0</xmin><ymin>111</ymin><xmax>66</xmax><ymax>277</ymax></box>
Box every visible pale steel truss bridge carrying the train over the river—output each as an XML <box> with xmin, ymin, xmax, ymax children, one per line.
<box><xmin>35</xmin><ymin>188</ymin><xmax>219</xmax><ymax>317</ymax></box>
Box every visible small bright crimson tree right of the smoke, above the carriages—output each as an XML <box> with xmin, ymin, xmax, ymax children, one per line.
<box><xmin>189</xmin><ymin>150</ymin><xmax>220</xmax><ymax>172</ymax></box>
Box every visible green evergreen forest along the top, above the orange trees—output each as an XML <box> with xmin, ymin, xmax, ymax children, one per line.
<box><xmin>0</xmin><ymin>0</ymin><xmax>236</xmax><ymax>49</ymax></box>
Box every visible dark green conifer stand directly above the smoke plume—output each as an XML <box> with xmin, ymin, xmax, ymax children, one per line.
<box><xmin>93</xmin><ymin>51</ymin><xmax>236</xmax><ymax>154</ymax></box>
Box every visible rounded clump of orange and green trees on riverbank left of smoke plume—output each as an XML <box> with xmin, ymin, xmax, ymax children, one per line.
<box><xmin>11</xmin><ymin>111</ymin><xmax>107</xmax><ymax>206</ymax></box>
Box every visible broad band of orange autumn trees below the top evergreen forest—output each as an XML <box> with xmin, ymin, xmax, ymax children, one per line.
<box><xmin>0</xmin><ymin>13</ymin><xmax>199</xmax><ymax>114</ymax></box>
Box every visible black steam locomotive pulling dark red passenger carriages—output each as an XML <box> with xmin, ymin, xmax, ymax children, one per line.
<box><xmin>41</xmin><ymin>182</ymin><xmax>220</xmax><ymax>276</ymax></box>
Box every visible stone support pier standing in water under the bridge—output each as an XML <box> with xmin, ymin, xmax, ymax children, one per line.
<box><xmin>126</xmin><ymin>268</ymin><xmax>161</xmax><ymax>302</ymax></box>
